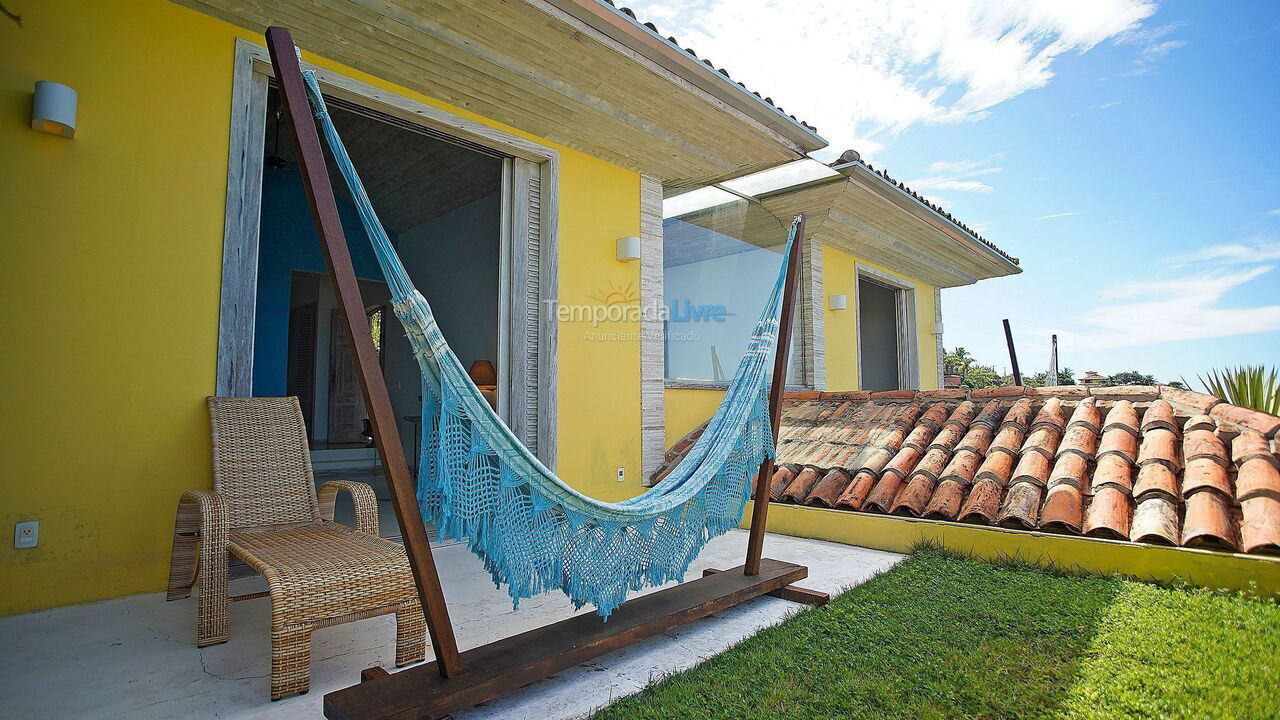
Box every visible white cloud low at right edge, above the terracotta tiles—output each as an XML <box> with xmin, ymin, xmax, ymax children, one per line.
<box><xmin>1059</xmin><ymin>265</ymin><xmax>1280</xmax><ymax>351</ymax></box>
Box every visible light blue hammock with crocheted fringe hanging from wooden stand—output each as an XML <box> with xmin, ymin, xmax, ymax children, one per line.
<box><xmin>303</xmin><ymin>72</ymin><xmax>796</xmax><ymax>619</ymax></box>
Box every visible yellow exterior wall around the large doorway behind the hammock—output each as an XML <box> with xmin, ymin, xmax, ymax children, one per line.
<box><xmin>0</xmin><ymin>0</ymin><xmax>640</xmax><ymax>615</ymax></box>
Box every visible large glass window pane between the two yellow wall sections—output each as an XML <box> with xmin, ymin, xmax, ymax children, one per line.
<box><xmin>663</xmin><ymin>187</ymin><xmax>799</xmax><ymax>382</ymax></box>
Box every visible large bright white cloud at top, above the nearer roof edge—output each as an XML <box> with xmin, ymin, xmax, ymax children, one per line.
<box><xmin>631</xmin><ymin>0</ymin><xmax>1162</xmax><ymax>158</ymax></box>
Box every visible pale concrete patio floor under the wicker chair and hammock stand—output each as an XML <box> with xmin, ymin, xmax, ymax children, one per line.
<box><xmin>0</xmin><ymin>530</ymin><xmax>902</xmax><ymax>720</ymax></box>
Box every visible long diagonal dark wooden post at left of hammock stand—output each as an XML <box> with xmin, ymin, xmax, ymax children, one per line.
<box><xmin>266</xmin><ymin>27</ymin><xmax>462</xmax><ymax>678</ymax></box>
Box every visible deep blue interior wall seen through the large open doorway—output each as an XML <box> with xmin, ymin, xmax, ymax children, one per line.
<box><xmin>253</xmin><ymin>168</ymin><xmax>397</xmax><ymax>397</ymax></box>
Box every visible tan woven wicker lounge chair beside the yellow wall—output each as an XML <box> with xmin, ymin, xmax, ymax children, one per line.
<box><xmin>168</xmin><ymin>397</ymin><xmax>426</xmax><ymax>700</ymax></box>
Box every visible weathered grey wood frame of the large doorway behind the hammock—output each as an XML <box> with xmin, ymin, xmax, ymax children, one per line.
<box><xmin>215</xmin><ymin>38</ymin><xmax>559</xmax><ymax>469</ymax></box>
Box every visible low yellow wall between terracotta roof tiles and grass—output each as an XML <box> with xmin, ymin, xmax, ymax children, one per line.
<box><xmin>742</xmin><ymin>502</ymin><xmax>1280</xmax><ymax>597</ymax></box>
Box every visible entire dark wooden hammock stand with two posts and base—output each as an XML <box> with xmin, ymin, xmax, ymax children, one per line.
<box><xmin>266</xmin><ymin>27</ymin><xmax>828</xmax><ymax>720</ymax></box>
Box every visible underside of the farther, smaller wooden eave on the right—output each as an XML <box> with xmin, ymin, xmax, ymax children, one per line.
<box><xmin>759</xmin><ymin>164</ymin><xmax>1021</xmax><ymax>287</ymax></box>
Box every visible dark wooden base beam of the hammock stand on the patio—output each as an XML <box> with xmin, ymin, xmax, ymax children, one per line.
<box><xmin>324</xmin><ymin>559</ymin><xmax>808</xmax><ymax>720</ymax></box>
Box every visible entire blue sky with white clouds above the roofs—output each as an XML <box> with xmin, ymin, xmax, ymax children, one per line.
<box><xmin>632</xmin><ymin>0</ymin><xmax>1280</xmax><ymax>383</ymax></box>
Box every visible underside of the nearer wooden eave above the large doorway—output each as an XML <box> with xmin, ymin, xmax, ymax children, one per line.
<box><xmin>175</xmin><ymin>0</ymin><xmax>826</xmax><ymax>187</ymax></box>
